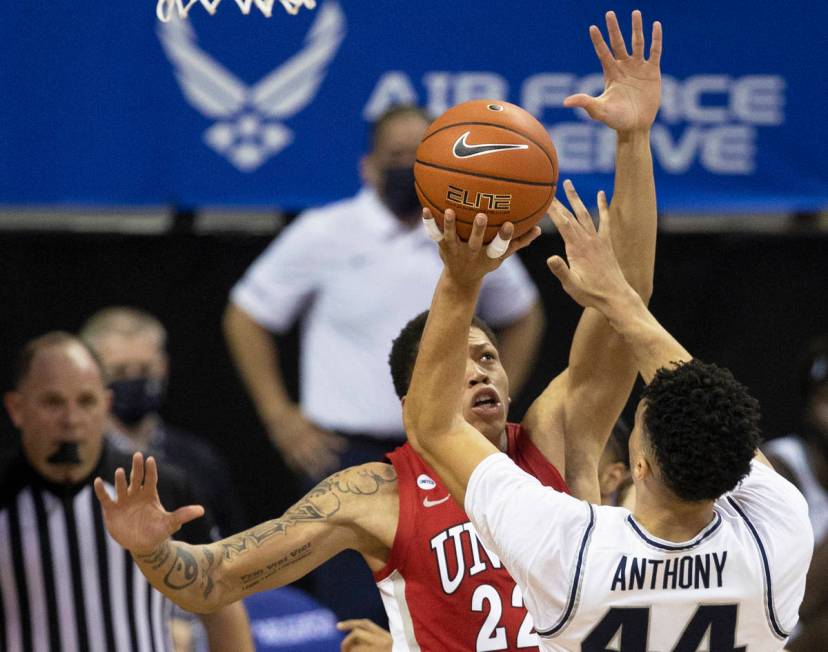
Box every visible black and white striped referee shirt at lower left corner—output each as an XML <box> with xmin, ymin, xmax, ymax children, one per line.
<box><xmin>0</xmin><ymin>444</ymin><xmax>210</xmax><ymax>652</ymax></box>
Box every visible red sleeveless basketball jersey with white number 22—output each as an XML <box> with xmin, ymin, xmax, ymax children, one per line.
<box><xmin>374</xmin><ymin>423</ymin><xmax>569</xmax><ymax>652</ymax></box>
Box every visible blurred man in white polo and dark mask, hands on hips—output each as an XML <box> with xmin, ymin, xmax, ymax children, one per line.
<box><xmin>224</xmin><ymin>105</ymin><xmax>544</xmax><ymax>624</ymax></box>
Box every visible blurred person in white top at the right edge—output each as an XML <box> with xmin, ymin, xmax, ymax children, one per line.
<box><xmin>763</xmin><ymin>335</ymin><xmax>828</xmax><ymax>652</ymax></box>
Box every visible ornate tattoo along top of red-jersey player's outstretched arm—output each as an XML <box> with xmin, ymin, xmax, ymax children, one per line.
<box><xmin>221</xmin><ymin>464</ymin><xmax>397</xmax><ymax>570</ymax></box>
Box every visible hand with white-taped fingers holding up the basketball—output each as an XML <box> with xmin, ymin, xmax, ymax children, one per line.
<box><xmin>423</xmin><ymin>208</ymin><xmax>540</xmax><ymax>285</ymax></box>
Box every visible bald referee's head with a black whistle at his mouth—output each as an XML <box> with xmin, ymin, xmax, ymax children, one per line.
<box><xmin>6</xmin><ymin>342</ymin><xmax>111</xmax><ymax>483</ymax></box>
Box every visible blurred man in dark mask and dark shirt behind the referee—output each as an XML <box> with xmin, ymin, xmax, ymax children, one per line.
<box><xmin>80</xmin><ymin>306</ymin><xmax>248</xmax><ymax>538</ymax></box>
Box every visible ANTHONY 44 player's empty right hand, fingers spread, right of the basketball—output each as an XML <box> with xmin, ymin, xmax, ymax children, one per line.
<box><xmin>546</xmin><ymin>179</ymin><xmax>635</xmax><ymax>310</ymax></box>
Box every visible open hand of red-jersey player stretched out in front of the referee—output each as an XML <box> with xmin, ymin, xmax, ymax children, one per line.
<box><xmin>95</xmin><ymin>453</ymin><xmax>204</xmax><ymax>555</ymax></box>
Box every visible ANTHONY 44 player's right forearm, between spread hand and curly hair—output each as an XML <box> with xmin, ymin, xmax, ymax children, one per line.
<box><xmin>600</xmin><ymin>288</ymin><xmax>693</xmax><ymax>383</ymax></box>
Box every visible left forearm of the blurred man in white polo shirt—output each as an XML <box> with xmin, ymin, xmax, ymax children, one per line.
<box><xmin>224</xmin><ymin>304</ymin><xmax>293</xmax><ymax>424</ymax></box>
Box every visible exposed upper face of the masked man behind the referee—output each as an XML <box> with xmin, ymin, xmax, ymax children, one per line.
<box><xmin>95</xmin><ymin>330</ymin><xmax>167</xmax><ymax>381</ymax></box>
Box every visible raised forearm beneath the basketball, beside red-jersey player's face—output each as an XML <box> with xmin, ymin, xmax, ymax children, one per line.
<box><xmin>403</xmin><ymin>270</ymin><xmax>481</xmax><ymax>450</ymax></box>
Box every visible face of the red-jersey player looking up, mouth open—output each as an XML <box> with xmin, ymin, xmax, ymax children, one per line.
<box><xmin>463</xmin><ymin>326</ymin><xmax>509</xmax><ymax>444</ymax></box>
